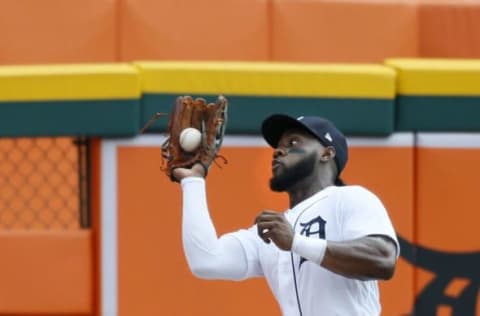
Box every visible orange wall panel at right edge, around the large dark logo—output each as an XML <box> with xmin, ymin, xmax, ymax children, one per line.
<box><xmin>415</xmin><ymin>147</ymin><xmax>480</xmax><ymax>316</ymax></box>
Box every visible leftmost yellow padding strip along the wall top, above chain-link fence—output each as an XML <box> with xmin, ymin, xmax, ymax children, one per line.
<box><xmin>0</xmin><ymin>64</ymin><xmax>140</xmax><ymax>101</ymax></box>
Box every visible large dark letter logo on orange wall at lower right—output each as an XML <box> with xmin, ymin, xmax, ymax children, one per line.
<box><xmin>398</xmin><ymin>236</ymin><xmax>480</xmax><ymax>316</ymax></box>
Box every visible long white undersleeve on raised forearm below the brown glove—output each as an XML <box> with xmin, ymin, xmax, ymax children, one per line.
<box><xmin>181</xmin><ymin>178</ymin><xmax>246</xmax><ymax>280</ymax></box>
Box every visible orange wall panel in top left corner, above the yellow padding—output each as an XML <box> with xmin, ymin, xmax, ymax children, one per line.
<box><xmin>0</xmin><ymin>0</ymin><xmax>118</xmax><ymax>64</ymax></box>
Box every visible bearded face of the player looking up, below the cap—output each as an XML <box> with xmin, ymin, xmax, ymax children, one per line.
<box><xmin>270</xmin><ymin>130</ymin><xmax>321</xmax><ymax>192</ymax></box>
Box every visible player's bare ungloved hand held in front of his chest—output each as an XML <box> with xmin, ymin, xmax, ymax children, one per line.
<box><xmin>255</xmin><ymin>211</ymin><xmax>294</xmax><ymax>250</ymax></box>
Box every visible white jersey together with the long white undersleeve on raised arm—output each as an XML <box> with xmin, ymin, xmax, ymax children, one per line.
<box><xmin>182</xmin><ymin>178</ymin><xmax>400</xmax><ymax>316</ymax></box>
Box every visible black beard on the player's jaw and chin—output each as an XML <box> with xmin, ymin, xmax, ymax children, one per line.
<box><xmin>270</xmin><ymin>152</ymin><xmax>317</xmax><ymax>192</ymax></box>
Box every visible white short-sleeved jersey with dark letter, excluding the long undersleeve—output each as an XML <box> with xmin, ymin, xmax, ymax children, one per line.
<box><xmin>227</xmin><ymin>186</ymin><xmax>399</xmax><ymax>316</ymax></box>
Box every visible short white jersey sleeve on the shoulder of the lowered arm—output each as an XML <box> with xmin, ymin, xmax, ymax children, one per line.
<box><xmin>339</xmin><ymin>186</ymin><xmax>400</xmax><ymax>256</ymax></box>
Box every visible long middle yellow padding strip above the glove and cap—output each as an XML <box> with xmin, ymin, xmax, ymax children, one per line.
<box><xmin>135</xmin><ymin>62</ymin><xmax>395</xmax><ymax>98</ymax></box>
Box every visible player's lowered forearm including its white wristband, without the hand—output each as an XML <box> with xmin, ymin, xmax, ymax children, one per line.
<box><xmin>292</xmin><ymin>235</ymin><xmax>396</xmax><ymax>280</ymax></box>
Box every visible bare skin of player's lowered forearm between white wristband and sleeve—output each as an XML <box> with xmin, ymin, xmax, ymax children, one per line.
<box><xmin>321</xmin><ymin>237</ymin><xmax>396</xmax><ymax>280</ymax></box>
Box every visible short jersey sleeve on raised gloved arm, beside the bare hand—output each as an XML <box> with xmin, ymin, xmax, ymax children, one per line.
<box><xmin>225</xmin><ymin>225</ymin><xmax>264</xmax><ymax>278</ymax></box>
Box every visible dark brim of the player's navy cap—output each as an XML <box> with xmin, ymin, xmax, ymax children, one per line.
<box><xmin>262</xmin><ymin>114</ymin><xmax>312</xmax><ymax>148</ymax></box>
